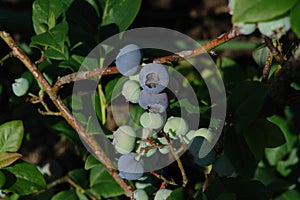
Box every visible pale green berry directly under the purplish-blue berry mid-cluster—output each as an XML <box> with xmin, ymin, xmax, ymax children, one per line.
<box><xmin>140</xmin><ymin>112</ymin><xmax>164</xmax><ymax>129</ymax></box>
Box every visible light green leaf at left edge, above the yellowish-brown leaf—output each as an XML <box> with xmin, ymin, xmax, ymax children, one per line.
<box><xmin>0</xmin><ymin>120</ymin><xmax>24</xmax><ymax>152</ymax></box>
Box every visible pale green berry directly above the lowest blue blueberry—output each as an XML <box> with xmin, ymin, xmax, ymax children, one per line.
<box><xmin>113</xmin><ymin>125</ymin><xmax>136</xmax><ymax>154</ymax></box>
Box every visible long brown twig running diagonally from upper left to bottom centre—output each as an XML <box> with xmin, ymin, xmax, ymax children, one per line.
<box><xmin>0</xmin><ymin>30</ymin><xmax>133</xmax><ymax>197</ymax></box>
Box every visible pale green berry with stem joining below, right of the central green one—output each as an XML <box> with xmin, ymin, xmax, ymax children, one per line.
<box><xmin>164</xmin><ymin>117</ymin><xmax>189</xmax><ymax>139</ymax></box>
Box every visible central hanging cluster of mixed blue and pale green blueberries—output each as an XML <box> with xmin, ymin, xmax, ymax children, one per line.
<box><xmin>113</xmin><ymin>44</ymin><xmax>217</xmax><ymax>180</ymax></box>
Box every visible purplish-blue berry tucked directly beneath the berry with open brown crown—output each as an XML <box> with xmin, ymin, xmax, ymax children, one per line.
<box><xmin>139</xmin><ymin>90</ymin><xmax>169</xmax><ymax>113</ymax></box>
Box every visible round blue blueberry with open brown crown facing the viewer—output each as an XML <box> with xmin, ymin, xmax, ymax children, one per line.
<box><xmin>140</xmin><ymin>63</ymin><xmax>169</xmax><ymax>94</ymax></box>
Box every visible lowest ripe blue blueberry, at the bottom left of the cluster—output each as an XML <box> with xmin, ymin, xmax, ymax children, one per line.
<box><xmin>118</xmin><ymin>153</ymin><xmax>144</xmax><ymax>180</ymax></box>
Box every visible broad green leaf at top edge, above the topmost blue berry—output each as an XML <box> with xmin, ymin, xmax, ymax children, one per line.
<box><xmin>100</xmin><ymin>0</ymin><xmax>142</xmax><ymax>32</ymax></box>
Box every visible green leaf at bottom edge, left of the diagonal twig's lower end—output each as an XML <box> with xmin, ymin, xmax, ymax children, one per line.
<box><xmin>87</xmin><ymin>164</ymin><xmax>124</xmax><ymax>198</ymax></box>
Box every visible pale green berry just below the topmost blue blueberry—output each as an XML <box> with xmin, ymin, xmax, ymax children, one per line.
<box><xmin>122</xmin><ymin>80</ymin><xmax>141</xmax><ymax>103</ymax></box>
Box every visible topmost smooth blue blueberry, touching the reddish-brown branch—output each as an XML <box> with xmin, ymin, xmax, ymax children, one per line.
<box><xmin>116</xmin><ymin>44</ymin><xmax>142</xmax><ymax>76</ymax></box>
